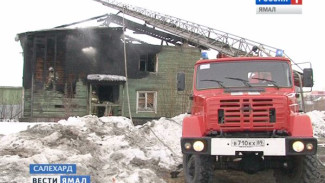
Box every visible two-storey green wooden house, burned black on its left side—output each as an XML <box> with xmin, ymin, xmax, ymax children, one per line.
<box><xmin>18</xmin><ymin>27</ymin><xmax>201</xmax><ymax>121</ymax></box>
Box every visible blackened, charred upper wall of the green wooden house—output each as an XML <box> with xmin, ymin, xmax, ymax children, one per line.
<box><xmin>20</xmin><ymin>28</ymin><xmax>161</xmax><ymax>92</ymax></box>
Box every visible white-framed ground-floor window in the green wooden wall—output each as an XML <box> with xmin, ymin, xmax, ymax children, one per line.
<box><xmin>137</xmin><ymin>91</ymin><xmax>157</xmax><ymax>112</ymax></box>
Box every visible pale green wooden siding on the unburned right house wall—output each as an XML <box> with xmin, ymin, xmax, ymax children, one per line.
<box><xmin>123</xmin><ymin>46</ymin><xmax>201</xmax><ymax>118</ymax></box>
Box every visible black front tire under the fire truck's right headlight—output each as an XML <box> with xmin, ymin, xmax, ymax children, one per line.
<box><xmin>274</xmin><ymin>155</ymin><xmax>320</xmax><ymax>183</ymax></box>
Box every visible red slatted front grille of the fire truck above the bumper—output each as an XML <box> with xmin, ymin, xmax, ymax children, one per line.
<box><xmin>207</xmin><ymin>98</ymin><xmax>285</xmax><ymax>129</ymax></box>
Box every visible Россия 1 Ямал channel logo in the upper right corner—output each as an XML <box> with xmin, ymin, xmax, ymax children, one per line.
<box><xmin>255</xmin><ymin>0</ymin><xmax>302</xmax><ymax>14</ymax></box>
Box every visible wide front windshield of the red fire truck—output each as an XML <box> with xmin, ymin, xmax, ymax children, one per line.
<box><xmin>196</xmin><ymin>61</ymin><xmax>292</xmax><ymax>90</ymax></box>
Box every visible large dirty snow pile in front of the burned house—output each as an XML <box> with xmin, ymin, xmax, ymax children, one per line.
<box><xmin>0</xmin><ymin>115</ymin><xmax>185</xmax><ymax>183</ymax></box>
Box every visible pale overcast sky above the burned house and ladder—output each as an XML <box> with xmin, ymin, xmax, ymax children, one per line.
<box><xmin>0</xmin><ymin>0</ymin><xmax>325</xmax><ymax>90</ymax></box>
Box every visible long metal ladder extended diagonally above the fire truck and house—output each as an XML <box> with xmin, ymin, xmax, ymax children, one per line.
<box><xmin>94</xmin><ymin>0</ymin><xmax>277</xmax><ymax>56</ymax></box>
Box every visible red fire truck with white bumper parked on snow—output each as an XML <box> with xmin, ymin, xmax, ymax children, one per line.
<box><xmin>178</xmin><ymin>57</ymin><xmax>317</xmax><ymax>183</ymax></box>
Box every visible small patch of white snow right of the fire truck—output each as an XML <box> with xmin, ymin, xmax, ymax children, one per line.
<box><xmin>307</xmin><ymin>111</ymin><xmax>325</xmax><ymax>138</ymax></box>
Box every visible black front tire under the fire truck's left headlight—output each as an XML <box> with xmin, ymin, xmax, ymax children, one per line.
<box><xmin>183</xmin><ymin>154</ymin><xmax>214</xmax><ymax>183</ymax></box>
